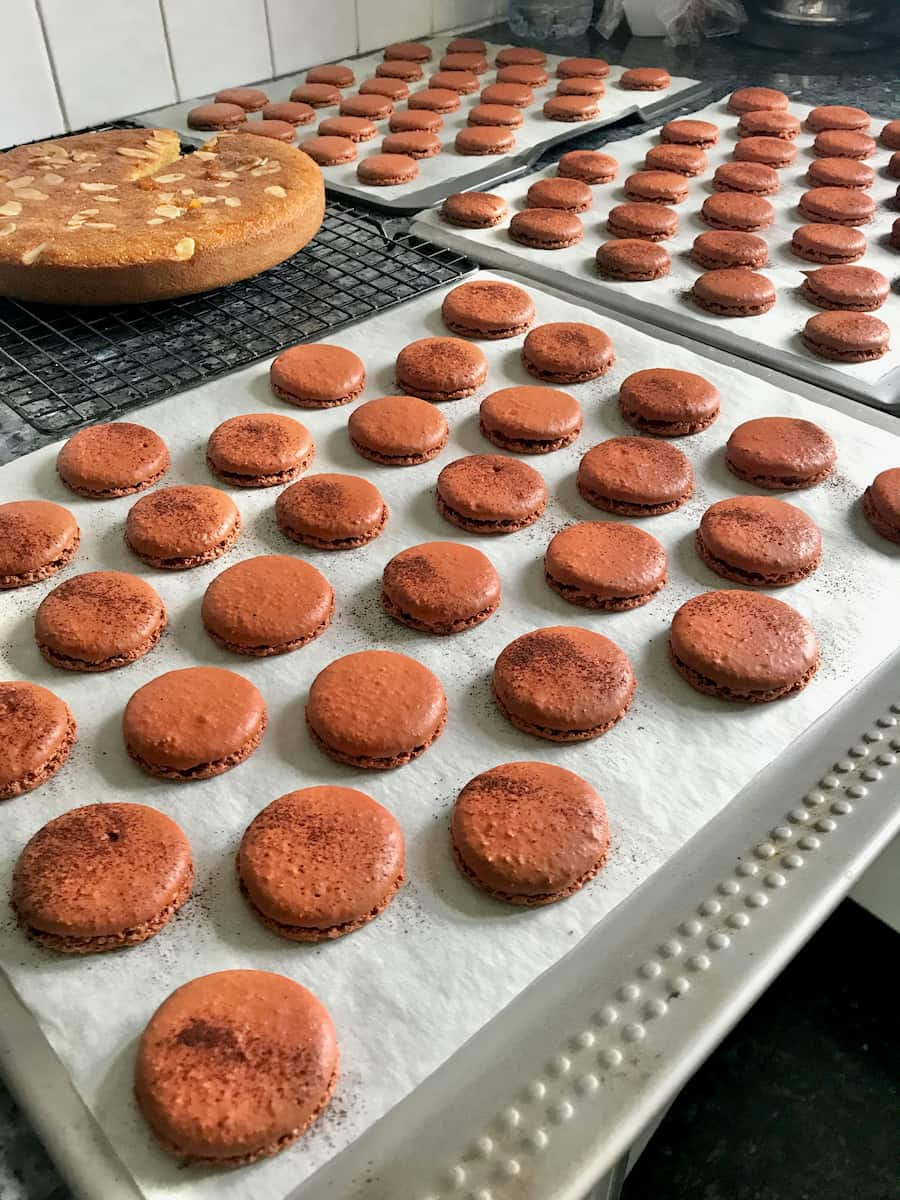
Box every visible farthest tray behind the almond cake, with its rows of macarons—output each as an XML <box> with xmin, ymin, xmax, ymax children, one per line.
<box><xmin>142</xmin><ymin>37</ymin><xmax>708</xmax><ymax>214</ymax></box>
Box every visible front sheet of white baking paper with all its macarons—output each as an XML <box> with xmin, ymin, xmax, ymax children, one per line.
<box><xmin>0</xmin><ymin>272</ymin><xmax>900</xmax><ymax>1200</ymax></box>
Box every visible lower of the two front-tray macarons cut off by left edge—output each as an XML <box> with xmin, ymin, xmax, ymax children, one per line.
<box><xmin>0</xmin><ymin>680</ymin><xmax>76</xmax><ymax>800</ymax></box>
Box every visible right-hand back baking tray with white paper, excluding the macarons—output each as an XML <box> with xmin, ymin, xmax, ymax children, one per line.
<box><xmin>413</xmin><ymin>100</ymin><xmax>900</xmax><ymax>412</ymax></box>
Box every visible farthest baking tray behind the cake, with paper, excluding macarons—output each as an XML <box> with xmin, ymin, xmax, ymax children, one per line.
<box><xmin>139</xmin><ymin>35</ymin><xmax>709</xmax><ymax>215</ymax></box>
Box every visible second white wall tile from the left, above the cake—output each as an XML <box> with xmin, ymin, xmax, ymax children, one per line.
<box><xmin>40</xmin><ymin>0</ymin><xmax>176</xmax><ymax>128</ymax></box>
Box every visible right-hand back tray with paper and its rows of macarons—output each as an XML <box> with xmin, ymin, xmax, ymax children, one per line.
<box><xmin>418</xmin><ymin>88</ymin><xmax>900</xmax><ymax>408</ymax></box>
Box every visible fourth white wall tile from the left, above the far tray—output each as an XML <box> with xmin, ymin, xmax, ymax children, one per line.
<box><xmin>264</xmin><ymin>0</ymin><xmax>355</xmax><ymax>74</ymax></box>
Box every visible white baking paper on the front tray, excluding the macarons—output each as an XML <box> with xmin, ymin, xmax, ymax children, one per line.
<box><xmin>0</xmin><ymin>272</ymin><xmax>900</xmax><ymax>1200</ymax></box>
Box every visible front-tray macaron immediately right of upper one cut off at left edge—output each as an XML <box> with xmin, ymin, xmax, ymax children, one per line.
<box><xmin>125</xmin><ymin>485</ymin><xmax>241</xmax><ymax>571</ymax></box>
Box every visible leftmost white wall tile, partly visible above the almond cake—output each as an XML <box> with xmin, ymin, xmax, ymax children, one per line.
<box><xmin>0</xmin><ymin>0</ymin><xmax>64</xmax><ymax>146</ymax></box>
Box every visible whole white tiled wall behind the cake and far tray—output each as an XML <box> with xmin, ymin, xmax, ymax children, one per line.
<box><xmin>0</xmin><ymin>0</ymin><xmax>494</xmax><ymax>145</ymax></box>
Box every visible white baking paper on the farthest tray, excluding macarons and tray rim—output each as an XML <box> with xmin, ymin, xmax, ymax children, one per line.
<box><xmin>142</xmin><ymin>35</ymin><xmax>697</xmax><ymax>206</ymax></box>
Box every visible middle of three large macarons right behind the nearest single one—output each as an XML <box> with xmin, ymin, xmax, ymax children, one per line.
<box><xmin>238</xmin><ymin>787</ymin><xmax>406</xmax><ymax>942</ymax></box>
